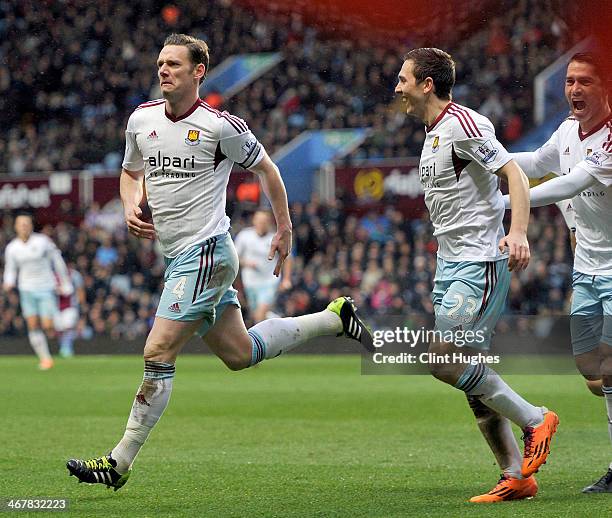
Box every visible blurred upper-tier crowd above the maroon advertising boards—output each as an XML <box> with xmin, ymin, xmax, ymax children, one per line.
<box><xmin>0</xmin><ymin>0</ymin><xmax>579</xmax><ymax>175</ymax></box>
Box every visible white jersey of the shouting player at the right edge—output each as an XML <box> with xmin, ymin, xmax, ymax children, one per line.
<box><xmin>516</xmin><ymin>117</ymin><xmax>612</xmax><ymax>275</ymax></box>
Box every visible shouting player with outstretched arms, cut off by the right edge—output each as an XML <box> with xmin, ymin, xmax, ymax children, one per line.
<box><xmin>506</xmin><ymin>52</ymin><xmax>612</xmax><ymax>493</ymax></box>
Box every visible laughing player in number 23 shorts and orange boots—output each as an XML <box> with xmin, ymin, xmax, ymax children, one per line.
<box><xmin>395</xmin><ymin>48</ymin><xmax>558</xmax><ymax>502</ymax></box>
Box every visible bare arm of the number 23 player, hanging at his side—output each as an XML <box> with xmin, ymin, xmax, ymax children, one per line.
<box><xmin>497</xmin><ymin>160</ymin><xmax>530</xmax><ymax>271</ymax></box>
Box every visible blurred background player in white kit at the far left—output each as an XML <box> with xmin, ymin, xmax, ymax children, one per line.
<box><xmin>4</xmin><ymin>214</ymin><xmax>72</xmax><ymax>370</ymax></box>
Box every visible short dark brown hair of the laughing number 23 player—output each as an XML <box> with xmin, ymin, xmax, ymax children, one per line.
<box><xmin>404</xmin><ymin>48</ymin><xmax>455</xmax><ymax>99</ymax></box>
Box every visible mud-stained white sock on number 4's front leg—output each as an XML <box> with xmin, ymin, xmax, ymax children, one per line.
<box><xmin>111</xmin><ymin>361</ymin><xmax>175</xmax><ymax>474</ymax></box>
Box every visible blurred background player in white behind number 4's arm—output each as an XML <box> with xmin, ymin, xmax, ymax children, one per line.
<box><xmin>236</xmin><ymin>210</ymin><xmax>291</xmax><ymax>323</ymax></box>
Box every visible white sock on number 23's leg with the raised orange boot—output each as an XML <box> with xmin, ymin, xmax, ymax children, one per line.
<box><xmin>455</xmin><ymin>364</ymin><xmax>544</xmax><ymax>430</ymax></box>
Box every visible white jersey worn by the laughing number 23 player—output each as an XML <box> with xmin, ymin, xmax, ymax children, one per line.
<box><xmin>419</xmin><ymin>102</ymin><xmax>511</xmax><ymax>261</ymax></box>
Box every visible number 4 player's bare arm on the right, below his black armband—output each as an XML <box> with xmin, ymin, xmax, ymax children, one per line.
<box><xmin>251</xmin><ymin>153</ymin><xmax>292</xmax><ymax>277</ymax></box>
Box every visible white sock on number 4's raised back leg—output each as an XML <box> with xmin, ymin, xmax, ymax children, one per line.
<box><xmin>249</xmin><ymin>309</ymin><xmax>342</xmax><ymax>365</ymax></box>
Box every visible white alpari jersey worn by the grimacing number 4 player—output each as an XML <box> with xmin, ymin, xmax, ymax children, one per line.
<box><xmin>123</xmin><ymin>99</ymin><xmax>265</xmax><ymax>258</ymax></box>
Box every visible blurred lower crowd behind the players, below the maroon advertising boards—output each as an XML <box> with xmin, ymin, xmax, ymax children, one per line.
<box><xmin>0</xmin><ymin>199</ymin><xmax>572</xmax><ymax>340</ymax></box>
